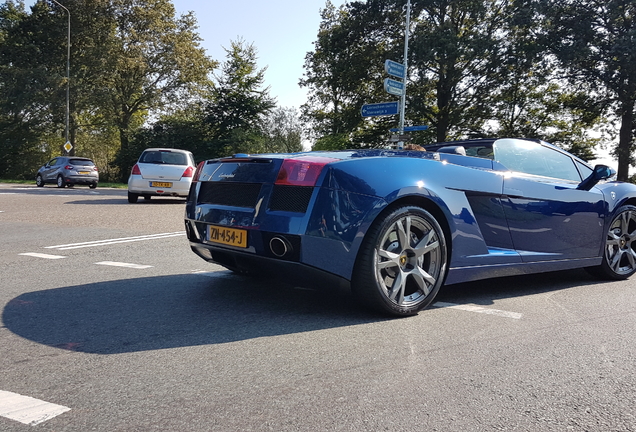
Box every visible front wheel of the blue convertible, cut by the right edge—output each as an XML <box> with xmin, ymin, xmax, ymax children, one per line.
<box><xmin>586</xmin><ymin>205</ymin><xmax>636</xmax><ymax>280</ymax></box>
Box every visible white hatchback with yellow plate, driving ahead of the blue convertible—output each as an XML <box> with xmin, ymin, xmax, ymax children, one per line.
<box><xmin>128</xmin><ymin>148</ymin><xmax>196</xmax><ymax>203</ymax></box>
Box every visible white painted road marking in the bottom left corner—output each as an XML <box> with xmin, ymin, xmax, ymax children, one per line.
<box><xmin>0</xmin><ymin>390</ymin><xmax>71</xmax><ymax>426</ymax></box>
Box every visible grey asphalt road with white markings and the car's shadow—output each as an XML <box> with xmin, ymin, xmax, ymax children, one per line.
<box><xmin>0</xmin><ymin>184</ymin><xmax>636</xmax><ymax>432</ymax></box>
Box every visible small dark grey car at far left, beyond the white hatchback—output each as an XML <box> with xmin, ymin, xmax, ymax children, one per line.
<box><xmin>35</xmin><ymin>156</ymin><xmax>99</xmax><ymax>189</ymax></box>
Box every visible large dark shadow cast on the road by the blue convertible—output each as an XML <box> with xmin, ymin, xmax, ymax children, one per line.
<box><xmin>2</xmin><ymin>272</ymin><xmax>386</xmax><ymax>354</ymax></box>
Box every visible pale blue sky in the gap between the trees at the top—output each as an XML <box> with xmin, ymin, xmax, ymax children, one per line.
<box><xmin>25</xmin><ymin>0</ymin><xmax>345</xmax><ymax>108</ymax></box>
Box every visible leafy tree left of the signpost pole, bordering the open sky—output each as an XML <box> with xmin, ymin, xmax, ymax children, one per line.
<box><xmin>300</xmin><ymin>0</ymin><xmax>404</xmax><ymax>148</ymax></box>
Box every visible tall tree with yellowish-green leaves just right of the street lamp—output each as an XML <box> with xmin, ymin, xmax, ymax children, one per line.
<box><xmin>102</xmin><ymin>0</ymin><xmax>216</xmax><ymax>179</ymax></box>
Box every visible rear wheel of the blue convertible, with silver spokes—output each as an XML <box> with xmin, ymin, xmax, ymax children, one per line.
<box><xmin>352</xmin><ymin>206</ymin><xmax>448</xmax><ymax>316</ymax></box>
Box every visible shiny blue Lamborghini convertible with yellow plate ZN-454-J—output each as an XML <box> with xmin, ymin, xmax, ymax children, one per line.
<box><xmin>185</xmin><ymin>139</ymin><xmax>636</xmax><ymax>315</ymax></box>
